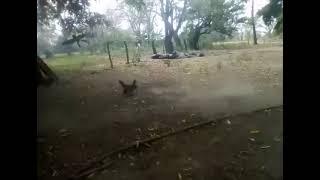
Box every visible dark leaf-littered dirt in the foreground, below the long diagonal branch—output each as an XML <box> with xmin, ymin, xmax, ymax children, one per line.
<box><xmin>94</xmin><ymin>108</ymin><xmax>283</xmax><ymax>180</ymax></box>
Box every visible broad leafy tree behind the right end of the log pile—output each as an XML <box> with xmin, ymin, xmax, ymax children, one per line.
<box><xmin>186</xmin><ymin>0</ymin><xmax>245</xmax><ymax>50</ymax></box>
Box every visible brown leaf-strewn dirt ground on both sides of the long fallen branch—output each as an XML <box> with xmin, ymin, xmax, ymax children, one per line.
<box><xmin>37</xmin><ymin>47</ymin><xmax>283</xmax><ymax>180</ymax></box>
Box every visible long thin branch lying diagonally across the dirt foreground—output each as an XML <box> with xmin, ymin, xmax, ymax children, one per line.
<box><xmin>73</xmin><ymin>105</ymin><xmax>283</xmax><ymax>177</ymax></box>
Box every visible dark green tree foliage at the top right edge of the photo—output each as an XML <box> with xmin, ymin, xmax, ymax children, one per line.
<box><xmin>257</xmin><ymin>0</ymin><xmax>283</xmax><ymax>34</ymax></box>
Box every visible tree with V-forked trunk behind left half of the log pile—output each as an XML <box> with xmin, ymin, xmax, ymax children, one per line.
<box><xmin>160</xmin><ymin>0</ymin><xmax>188</xmax><ymax>54</ymax></box>
